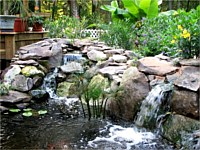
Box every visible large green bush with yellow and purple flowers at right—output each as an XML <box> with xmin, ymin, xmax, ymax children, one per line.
<box><xmin>135</xmin><ymin>7</ymin><xmax>200</xmax><ymax>58</ymax></box>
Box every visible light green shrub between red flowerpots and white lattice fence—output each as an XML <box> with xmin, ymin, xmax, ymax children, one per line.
<box><xmin>44</xmin><ymin>16</ymin><xmax>85</xmax><ymax>39</ymax></box>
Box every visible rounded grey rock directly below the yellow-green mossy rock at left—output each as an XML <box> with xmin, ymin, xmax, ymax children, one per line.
<box><xmin>11</xmin><ymin>75</ymin><xmax>33</xmax><ymax>92</ymax></box>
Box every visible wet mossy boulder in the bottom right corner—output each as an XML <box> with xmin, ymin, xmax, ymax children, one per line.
<box><xmin>161</xmin><ymin>115</ymin><xmax>200</xmax><ymax>150</ymax></box>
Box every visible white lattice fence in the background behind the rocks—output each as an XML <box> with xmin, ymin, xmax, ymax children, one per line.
<box><xmin>81</xmin><ymin>29</ymin><xmax>105</xmax><ymax>38</ymax></box>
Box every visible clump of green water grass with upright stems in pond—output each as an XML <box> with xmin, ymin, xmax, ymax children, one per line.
<box><xmin>72</xmin><ymin>73</ymin><xmax>109</xmax><ymax>120</ymax></box>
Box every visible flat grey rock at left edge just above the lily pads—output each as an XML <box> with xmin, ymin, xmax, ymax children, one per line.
<box><xmin>0</xmin><ymin>91</ymin><xmax>31</xmax><ymax>103</ymax></box>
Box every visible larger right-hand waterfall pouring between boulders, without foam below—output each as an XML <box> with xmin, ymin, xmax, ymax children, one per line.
<box><xmin>135</xmin><ymin>83</ymin><xmax>173</xmax><ymax>128</ymax></box>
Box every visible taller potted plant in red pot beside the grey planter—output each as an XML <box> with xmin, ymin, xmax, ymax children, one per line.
<box><xmin>10</xmin><ymin>0</ymin><xmax>29</xmax><ymax>32</ymax></box>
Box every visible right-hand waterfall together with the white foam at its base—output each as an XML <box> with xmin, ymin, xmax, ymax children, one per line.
<box><xmin>88</xmin><ymin>83</ymin><xmax>173</xmax><ymax>150</ymax></box>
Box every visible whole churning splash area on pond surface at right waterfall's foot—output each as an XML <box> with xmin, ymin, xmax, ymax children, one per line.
<box><xmin>88</xmin><ymin>122</ymin><xmax>172</xmax><ymax>150</ymax></box>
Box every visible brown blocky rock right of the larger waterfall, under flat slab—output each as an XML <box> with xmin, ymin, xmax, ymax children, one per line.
<box><xmin>171</xmin><ymin>88</ymin><xmax>200</xmax><ymax>119</ymax></box>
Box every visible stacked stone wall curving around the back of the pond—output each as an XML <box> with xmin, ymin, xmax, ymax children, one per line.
<box><xmin>0</xmin><ymin>39</ymin><xmax>200</xmax><ymax>120</ymax></box>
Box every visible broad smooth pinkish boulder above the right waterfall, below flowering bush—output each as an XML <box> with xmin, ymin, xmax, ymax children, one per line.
<box><xmin>137</xmin><ymin>57</ymin><xmax>178</xmax><ymax>76</ymax></box>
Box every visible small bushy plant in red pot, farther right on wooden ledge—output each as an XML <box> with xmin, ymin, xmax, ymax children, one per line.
<box><xmin>28</xmin><ymin>14</ymin><xmax>44</xmax><ymax>31</ymax></box>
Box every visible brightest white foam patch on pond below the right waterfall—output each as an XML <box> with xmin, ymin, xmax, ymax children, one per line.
<box><xmin>88</xmin><ymin>124</ymin><xmax>156</xmax><ymax>150</ymax></box>
